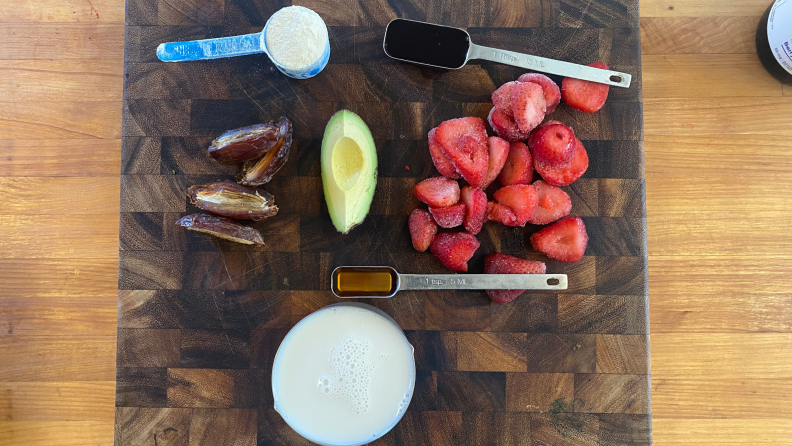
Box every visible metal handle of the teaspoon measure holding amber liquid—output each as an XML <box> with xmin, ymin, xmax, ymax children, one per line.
<box><xmin>399</xmin><ymin>274</ymin><xmax>567</xmax><ymax>290</ymax></box>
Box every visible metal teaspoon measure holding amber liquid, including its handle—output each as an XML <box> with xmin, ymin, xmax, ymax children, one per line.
<box><xmin>330</xmin><ymin>266</ymin><xmax>567</xmax><ymax>298</ymax></box>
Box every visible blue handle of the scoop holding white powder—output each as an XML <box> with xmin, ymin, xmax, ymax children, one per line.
<box><xmin>157</xmin><ymin>33</ymin><xmax>265</xmax><ymax>62</ymax></box>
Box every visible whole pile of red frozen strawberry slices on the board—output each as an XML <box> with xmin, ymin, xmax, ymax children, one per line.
<box><xmin>408</xmin><ymin>67</ymin><xmax>608</xmax><ymax>303</ymax></box>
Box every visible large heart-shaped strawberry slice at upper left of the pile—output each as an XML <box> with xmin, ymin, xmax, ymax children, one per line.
<box><xmin>436</xmin><ymin>117</ymin><xmax>489</xmax><ymax>187</ymax></box>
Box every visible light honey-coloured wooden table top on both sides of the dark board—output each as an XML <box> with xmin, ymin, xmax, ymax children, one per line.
<box><xmin>0</xmin><ymin>0</ymin><xmax>792</xmax><ymax>445</ymax></box>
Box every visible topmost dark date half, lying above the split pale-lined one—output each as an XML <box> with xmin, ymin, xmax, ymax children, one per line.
<box><xmin>209</xmin><ymin>117</ymin><xmax>291</xmax><ymax>164</ymax></box>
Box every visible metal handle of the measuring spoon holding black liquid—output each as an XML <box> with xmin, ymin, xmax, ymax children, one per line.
<box><xmin>468</xmin><ymin>43</ymin><xmax>632</xmax><ymax>88</ymax></box>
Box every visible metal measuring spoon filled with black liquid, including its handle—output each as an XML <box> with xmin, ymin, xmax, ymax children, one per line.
<box><xmin>382</xmin><ymin>19</ymin><xmax>632</xmax><ymax>88</ymax></box>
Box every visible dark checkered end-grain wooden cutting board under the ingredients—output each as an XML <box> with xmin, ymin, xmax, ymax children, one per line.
<box><xmin>116</xmin><ymin>0</ymin><xmax>651</xmax><ymax>446</ymax></box>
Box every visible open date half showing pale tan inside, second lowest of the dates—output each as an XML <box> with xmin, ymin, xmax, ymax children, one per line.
<box><xmin>187</xmin><ymin>180</ymin><xmax>278</xmax><ymax>221</ymax></box>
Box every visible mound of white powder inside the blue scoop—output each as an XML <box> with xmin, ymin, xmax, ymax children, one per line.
<box><xmin>266</xmin><ymin>6</ymin><xmax>328</xmax><ymax>70</ymax></box>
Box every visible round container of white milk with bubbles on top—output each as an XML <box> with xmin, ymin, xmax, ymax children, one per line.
<box><xmin>272</xmin><ymin>304</ymin><xmax>415</xmax><ymax>446</ymax></box>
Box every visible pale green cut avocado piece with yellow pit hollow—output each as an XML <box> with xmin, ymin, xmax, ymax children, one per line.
<box><xmin>322</xmin><ymin>110</ymin><xmax>377</xmax><ymax>234</ymax></box>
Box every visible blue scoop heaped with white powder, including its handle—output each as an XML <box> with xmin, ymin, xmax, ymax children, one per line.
<box><xmin>157</xmin><ymin>6</ymin><xmax>330</xmax><ymax>79</ymax></box>
